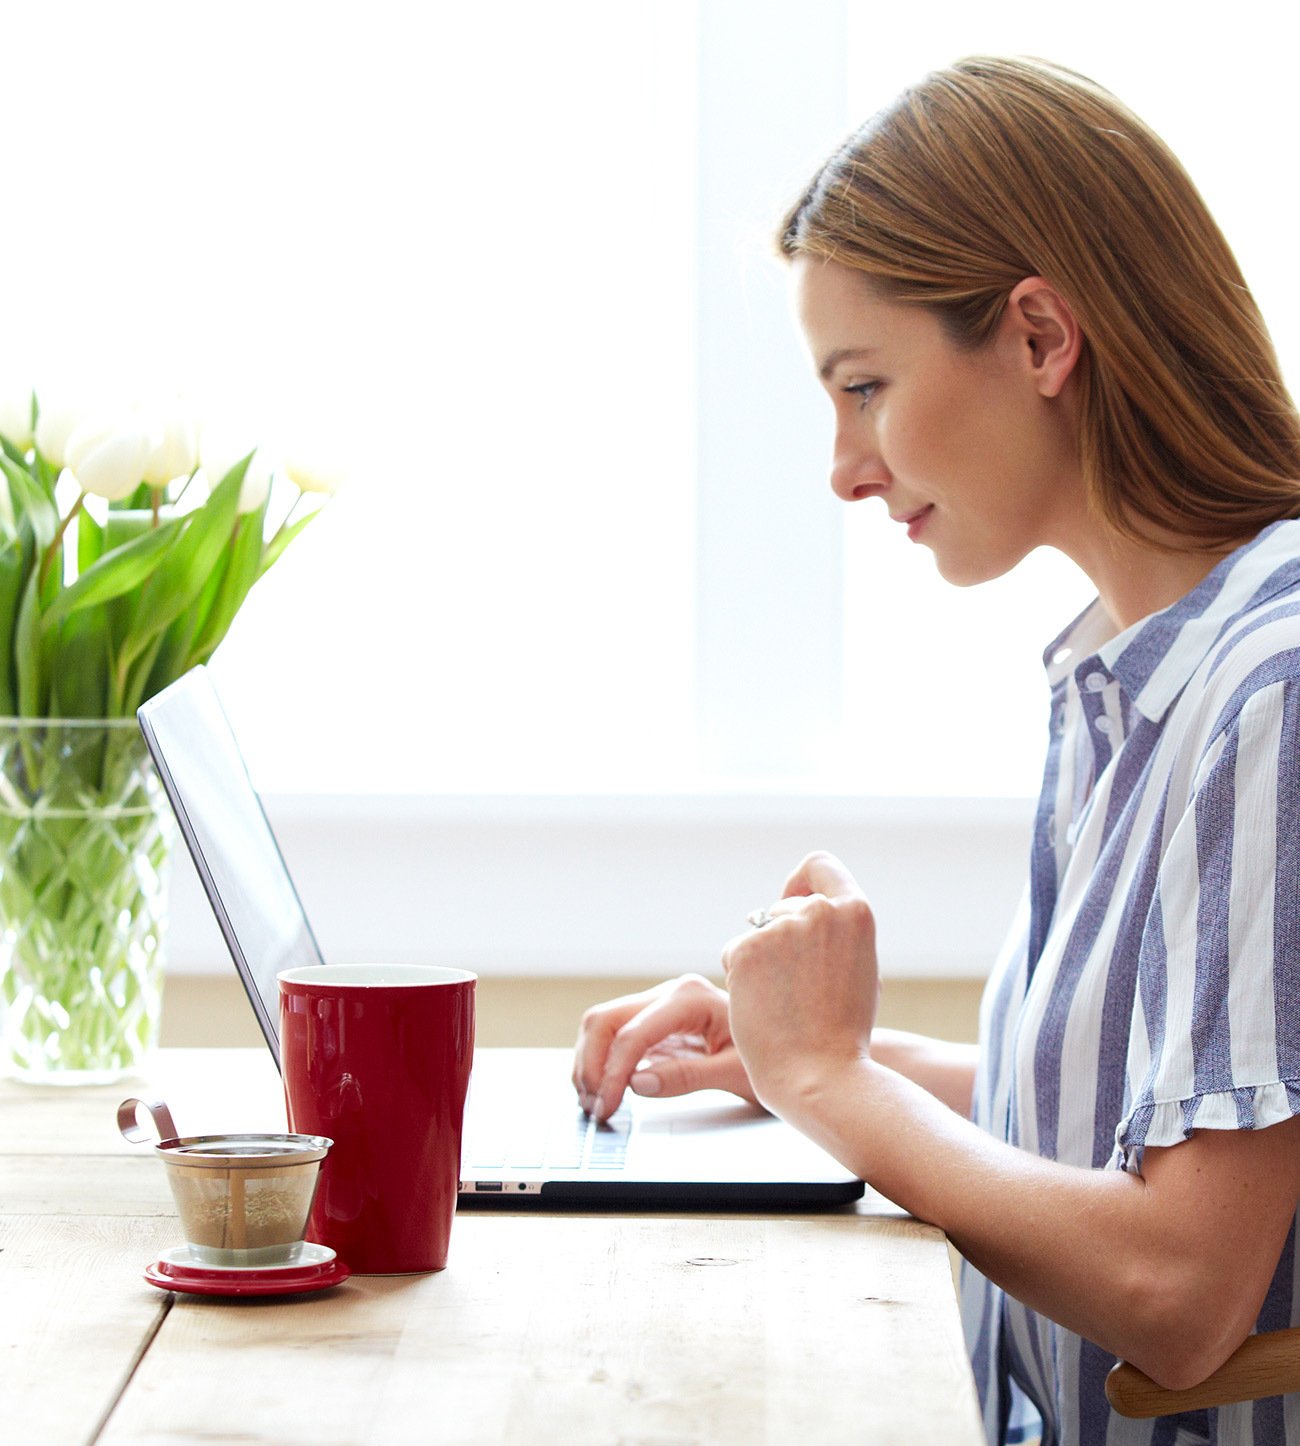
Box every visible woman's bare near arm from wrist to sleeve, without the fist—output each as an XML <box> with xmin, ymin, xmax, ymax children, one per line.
<box><xmin>765</xmin><ymin>1057</ymin><xmax>1300</xmax><ymax>1387</ymax></box>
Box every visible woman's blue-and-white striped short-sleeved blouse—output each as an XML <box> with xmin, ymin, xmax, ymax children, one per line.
<box><xmin>962</xmin><ymin>522</ymin><xmax>1300</xmax><ymax>1446</ymax></box>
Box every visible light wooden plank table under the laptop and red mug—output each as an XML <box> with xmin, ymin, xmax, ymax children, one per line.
<box><xmin>0</xmin><ymin>1050</ymin><xmax>982</xmax><ymax>1446</ymax></box>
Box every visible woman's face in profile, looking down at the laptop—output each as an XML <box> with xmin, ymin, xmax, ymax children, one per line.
<box><xmin>792</xmin><ymin>256</ymin><xmax>1089</xmax><ymax>586</ymax></box>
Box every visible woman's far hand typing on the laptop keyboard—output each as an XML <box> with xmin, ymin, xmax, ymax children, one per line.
<box><xmin>573</xmin><ymin>975</ymin><xmax>756</xmax><ymax>1119</ymax></box>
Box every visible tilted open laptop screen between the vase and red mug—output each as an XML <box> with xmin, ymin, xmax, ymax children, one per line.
<box><xmin>137</xmin><ymin>668</ymin><xmax>324</xmax><ymax>1064</ymax></box>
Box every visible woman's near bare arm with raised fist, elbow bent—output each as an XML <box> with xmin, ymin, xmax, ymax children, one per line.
<box><xmin>724</xmin><ymin>855</ymin><xmax>1300</xmax><ymax>1387</ymax></box>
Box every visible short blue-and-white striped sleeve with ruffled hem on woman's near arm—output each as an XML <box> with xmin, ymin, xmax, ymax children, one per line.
<box><xmin>1112</xmin><ymin>676</ymin><xmax>1300</xmax><ymax>1170</ymax></box>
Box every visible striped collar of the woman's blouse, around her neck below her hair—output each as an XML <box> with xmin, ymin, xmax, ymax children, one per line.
<box><xmin>1043</xmin><ymin>521</ymin><xmax>1300</xmax><ymax>723</ymax></box>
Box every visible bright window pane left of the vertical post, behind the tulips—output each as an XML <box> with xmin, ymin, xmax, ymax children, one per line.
<box><xmin>0</xmin><ymin>0</ymin><xmax>696</xmax><ymax>792</ymax></box>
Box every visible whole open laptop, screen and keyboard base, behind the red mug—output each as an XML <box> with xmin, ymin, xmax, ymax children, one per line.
<box><xmin>137</xmin><ymin>667</ymin><xmax>863</xmax><ymax>1209</ymax></box>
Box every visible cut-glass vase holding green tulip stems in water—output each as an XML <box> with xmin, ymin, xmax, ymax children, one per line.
<box><xmin>0</xmin><ymin>719</ymin><xmax>175</xmax><ymax>1085</ymax></box>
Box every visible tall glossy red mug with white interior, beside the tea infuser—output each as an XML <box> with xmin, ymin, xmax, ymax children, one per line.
<box><xmin>278</xmin><ymin>964</ymin><xmax>476</xmax><ymax>1275</ymax></box>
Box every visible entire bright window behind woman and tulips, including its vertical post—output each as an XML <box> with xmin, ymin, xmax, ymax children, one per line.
<box><xmin>0</xmin><ymin>0</ymin><xmax>1300</xmax><ymax>795</ymax></box>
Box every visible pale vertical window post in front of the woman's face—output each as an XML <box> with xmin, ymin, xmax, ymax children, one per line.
<box><xmin>696</xmin><ymin>0</ymin><xmax>847</xmax><ymax>781</ymax></box>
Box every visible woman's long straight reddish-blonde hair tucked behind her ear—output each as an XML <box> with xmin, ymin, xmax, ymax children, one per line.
<box><xmin>779</xmin><ymin>56</ymin><xmax>1300</xmax><ymax>548</ymax></box>
